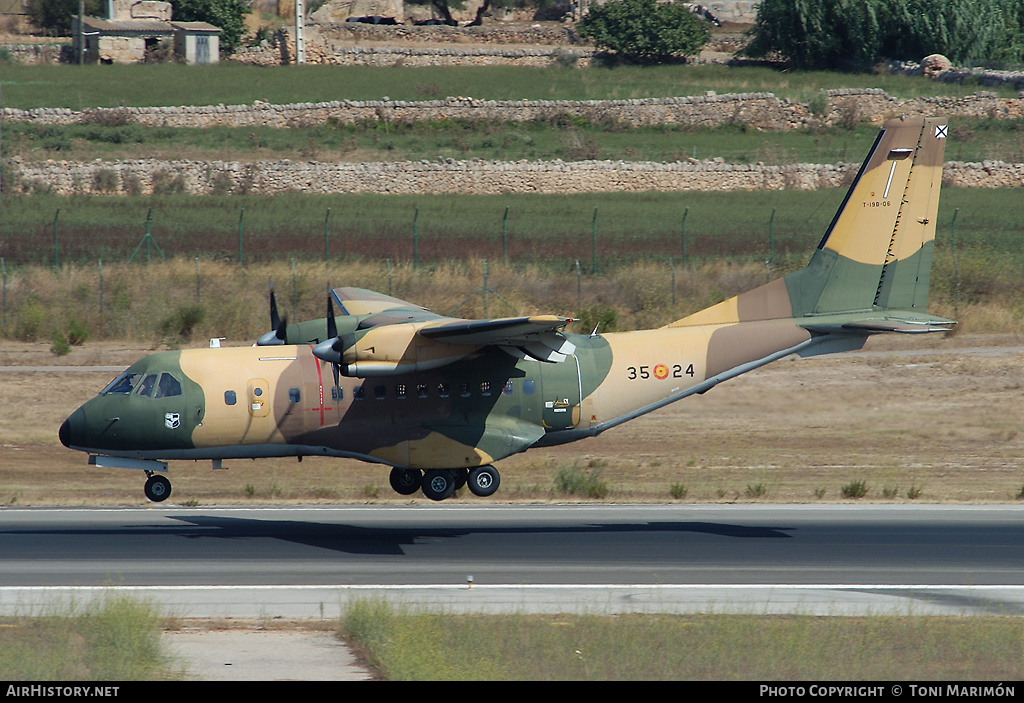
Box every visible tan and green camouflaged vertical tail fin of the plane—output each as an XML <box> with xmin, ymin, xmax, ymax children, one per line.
<box><xmin>670</xmin><ymin>118</ymin><xmax>948</xmax><ymax>332</ymax></box>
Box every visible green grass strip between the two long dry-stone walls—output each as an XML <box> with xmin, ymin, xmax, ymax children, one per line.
<box><xmin>4</xmin><ymin>119</ymin><xmax>1024</xmax><ymax>165</ymax></box>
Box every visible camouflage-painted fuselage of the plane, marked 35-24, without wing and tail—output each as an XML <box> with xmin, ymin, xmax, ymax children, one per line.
<box><xmin>61</xmin><ymin>323</ymin><xmax>809</xmax><ymax>469</ymax></box>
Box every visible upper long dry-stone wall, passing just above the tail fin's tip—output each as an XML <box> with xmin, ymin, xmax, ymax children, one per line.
<box><xmin>3</xmin><ymin>89</ymin><xmax>1024</xmax><ymax>131</ymax></box>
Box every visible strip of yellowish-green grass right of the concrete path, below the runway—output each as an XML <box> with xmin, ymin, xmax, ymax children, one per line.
<box><xmin>339</xmin><ymin>602</ymin><xmax>1024</xmax><ymax>679</ymax></box>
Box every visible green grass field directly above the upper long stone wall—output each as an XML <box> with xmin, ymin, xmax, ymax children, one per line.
<box><xmin>2</xmin><ymin>62</ymin><xmax>1017</xmax><ymax>109</ymax></box>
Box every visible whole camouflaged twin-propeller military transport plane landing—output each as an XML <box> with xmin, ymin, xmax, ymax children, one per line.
<box><xmin>59</xmin><ymin>118</ymin><xmax>953</xmax><ymax>501</ymax></box>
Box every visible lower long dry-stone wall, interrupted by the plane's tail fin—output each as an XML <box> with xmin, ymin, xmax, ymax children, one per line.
<box><xmin>5</xmin><ymin>159</ymin><xmax>1024</xmax><ymax>195</ymax></box>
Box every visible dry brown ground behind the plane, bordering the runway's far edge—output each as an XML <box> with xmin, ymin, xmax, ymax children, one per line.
<box><xmin>0</xmin><ymin>329</ymin><xmax>1024</xmax><ymax>507</ymax></box>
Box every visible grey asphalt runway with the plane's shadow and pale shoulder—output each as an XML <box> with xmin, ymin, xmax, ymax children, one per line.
<box><xmin>0</xmin><ymin>504</ymin><xmax>1024</xmax><ymax>618</ymax></box>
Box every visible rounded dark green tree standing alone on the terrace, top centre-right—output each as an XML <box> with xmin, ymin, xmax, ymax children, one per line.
<box><xmin>577</xmin><ymin>0</ymin><xmax>711</xmax><ymax>63</ymax></box>
